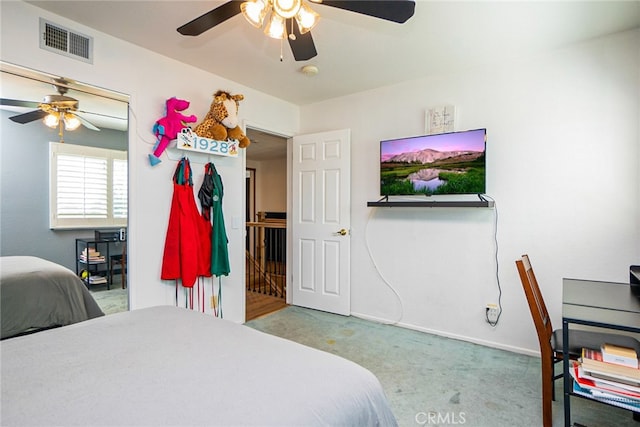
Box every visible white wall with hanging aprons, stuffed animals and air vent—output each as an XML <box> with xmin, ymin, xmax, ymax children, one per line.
<box><xmin>1</xmin><ymin>1</ymin><xmax>299</xmax><ymax>321</ymax></box>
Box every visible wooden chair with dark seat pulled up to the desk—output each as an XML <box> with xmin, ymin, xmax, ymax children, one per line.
<box><xmin>516</xmin><ymin>255</ymin><xmax>640</xmax><ymax>427</ymax></box>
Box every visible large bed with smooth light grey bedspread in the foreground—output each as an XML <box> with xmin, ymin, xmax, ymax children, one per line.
<box><xmin>0</xmin><ymin>306</ymin><xmax>397</xmax><ymax>426</ymax></box>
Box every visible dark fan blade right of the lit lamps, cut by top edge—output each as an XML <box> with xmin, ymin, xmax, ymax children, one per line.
<box><xmin>319</xmin><ymin>0</ymin><xmax>416</xmax><ymax>24</ymax></box>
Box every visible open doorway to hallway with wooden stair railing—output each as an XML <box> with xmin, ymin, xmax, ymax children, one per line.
<box><xmin>245</xmin><ymin>128</ymin><xmax>287</xmax><ymax>321</ymax></box>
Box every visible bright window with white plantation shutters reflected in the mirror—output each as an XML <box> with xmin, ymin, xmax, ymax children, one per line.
<box><xmin>50</xmin><ymin>142</ymin><xmax>127</xmax><ymax>229</ymax></box>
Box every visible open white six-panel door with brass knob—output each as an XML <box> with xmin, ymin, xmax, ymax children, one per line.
<box><xmin>289</xmin><ymin>129</ymin><xmax>351</xmax><ymax>315</ymax></box>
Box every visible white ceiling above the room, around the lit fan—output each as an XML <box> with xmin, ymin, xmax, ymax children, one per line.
<box><xmin>22</xmin><ymin>0</ymin><xmax>640</xmax><ymax>105</ymax></box>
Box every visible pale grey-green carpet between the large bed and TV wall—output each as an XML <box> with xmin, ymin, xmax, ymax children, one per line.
<box><xmin>246</xmin><ymin>306</ymin><xmax>640</xmax><ymax>427</ymax></box>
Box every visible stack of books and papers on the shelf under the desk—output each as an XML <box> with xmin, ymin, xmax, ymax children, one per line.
<box><xmin>571</xmin><ymin>344</ymin><xmax>640</xmax><ymax>412</ymax></box>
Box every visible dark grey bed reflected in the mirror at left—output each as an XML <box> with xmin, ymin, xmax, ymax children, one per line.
<box><xmin>0</xmin><ymin>256</ymin><xmax>104</xmax><ymax>339</ymax></box>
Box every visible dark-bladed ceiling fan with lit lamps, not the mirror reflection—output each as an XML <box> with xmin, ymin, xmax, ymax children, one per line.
<box><xmin>178</xmin><ymin>0</ymin><xmax>415</xmax><ymax>61</ymax></box>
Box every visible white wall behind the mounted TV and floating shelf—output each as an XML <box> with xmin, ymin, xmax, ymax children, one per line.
<box><xmin>301</xmin><ymin>31</ymin><xmax>640</xmax><ymax>352</ymax></box>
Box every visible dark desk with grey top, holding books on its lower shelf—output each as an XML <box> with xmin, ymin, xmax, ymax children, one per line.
<box><xmin>562</xmin><ymin>279</ymin><xmax>640</xmax><ymax>427</ymax></box>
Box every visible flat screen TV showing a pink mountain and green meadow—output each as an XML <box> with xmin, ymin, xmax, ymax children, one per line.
<box><xmin>380</xmin><ymin>129</ymin><xmax>487</xmax><ymax>196</ymax></box>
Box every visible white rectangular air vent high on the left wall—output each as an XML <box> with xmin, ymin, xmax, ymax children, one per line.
<box><xmin>40</xmin><ymin>18</ymin><xmax>93</xmax><ymax>64</ymax></box>
